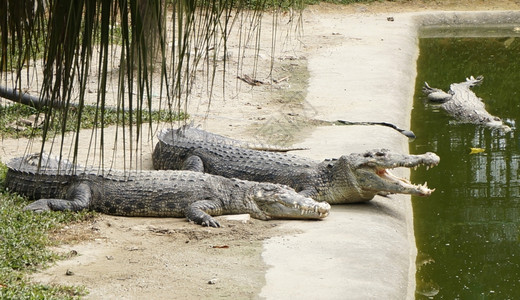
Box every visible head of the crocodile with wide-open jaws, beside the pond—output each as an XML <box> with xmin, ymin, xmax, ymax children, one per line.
<box><xmin>329</xmin><ymin>149</ymin><xmax>440</xmax><ymax>202</ymax></box>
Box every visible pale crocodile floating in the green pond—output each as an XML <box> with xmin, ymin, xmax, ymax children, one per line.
<box><xmin>423</xmin><ymin>75</ymin><xmax>511</xmax><ymax>132</ymax></box>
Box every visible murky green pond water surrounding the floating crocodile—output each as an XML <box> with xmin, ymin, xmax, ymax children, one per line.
<box><xmin>410</xmin><ymin>31</ymin><xmax>520</xmax><ymax>299</ymax></box>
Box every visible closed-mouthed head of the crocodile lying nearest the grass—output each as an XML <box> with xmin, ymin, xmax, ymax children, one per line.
<box><xmin>250</xmin><ymin>183</ymin><xmax>330</xmax><ymax>220</ymax></box>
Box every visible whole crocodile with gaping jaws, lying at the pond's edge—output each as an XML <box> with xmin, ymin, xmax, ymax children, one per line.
<box><xmin>153</xmin><ymin>126</ymin><xmax>439</xmax><ymax>204</ymax></box>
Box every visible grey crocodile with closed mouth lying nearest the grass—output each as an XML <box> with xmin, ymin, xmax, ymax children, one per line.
<box><xmin>5</xmin><ymin>154</ymin><xmax>330</xmax><ymax>227</ymax></box>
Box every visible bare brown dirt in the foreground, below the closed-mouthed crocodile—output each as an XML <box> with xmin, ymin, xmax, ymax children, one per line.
<box><xmin>33</xmin><ymin>215</ymin><xmax>298</xmax><ymax>299</ymax></box>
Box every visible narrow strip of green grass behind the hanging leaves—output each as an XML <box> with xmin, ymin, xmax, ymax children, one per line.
<box><xmin>0</xmin><ymin>103</ymin><xmax>188</xmax><ymax>138</ymax></box>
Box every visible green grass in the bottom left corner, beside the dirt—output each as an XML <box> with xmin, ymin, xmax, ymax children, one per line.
<box><xmin>0</xmin><ymin>164</ymin><xmax>94</xmax><ymax>299</ymax></box>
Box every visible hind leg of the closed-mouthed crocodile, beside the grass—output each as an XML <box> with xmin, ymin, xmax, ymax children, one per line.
<box><xmin>24</xmin><ymin>183</ymin><xmax>92</xmax><ymax>213</ymax></box>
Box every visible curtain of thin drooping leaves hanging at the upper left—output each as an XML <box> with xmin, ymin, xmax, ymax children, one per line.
<box><xmin>0</xmin><ymin>0</ymin><xmax>302</xmax><ymax>169</ymax></box>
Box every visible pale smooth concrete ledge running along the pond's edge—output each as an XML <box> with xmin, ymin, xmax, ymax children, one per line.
<box><xmin>260</xmin><ymin>10</ymin><xmax>520</xmax><ymax>299</ymax></box>
